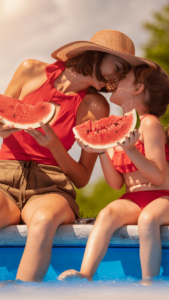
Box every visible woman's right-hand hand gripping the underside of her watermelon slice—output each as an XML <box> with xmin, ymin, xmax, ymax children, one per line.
<box><xmin>24</xmin><ymin>122</ymin><xmax>59</xmax><ymax>150</ymax></box>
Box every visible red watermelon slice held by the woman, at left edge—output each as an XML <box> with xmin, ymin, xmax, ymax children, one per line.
<box><xmin>0</xmin><ymin>95</ymin><xmax>55</xmax><ymax>129</ymax></box>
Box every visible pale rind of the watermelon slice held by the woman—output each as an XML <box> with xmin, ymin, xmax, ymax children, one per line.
<box><xmin>0</xmin><ymin>103</ymin><xmax>56</xmax><ymax>129</ymax></box>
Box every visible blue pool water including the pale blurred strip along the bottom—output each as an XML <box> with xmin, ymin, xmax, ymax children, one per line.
<box><xmin>0</xmin><ymin>247</ymin><xmax>169</xmax><ymax>300</ymax></box>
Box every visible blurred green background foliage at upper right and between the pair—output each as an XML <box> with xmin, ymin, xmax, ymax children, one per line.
<box><xmin>77</xmin><ymin>3</ymin><xmax>169</xmax><ymax>218</ymax></box>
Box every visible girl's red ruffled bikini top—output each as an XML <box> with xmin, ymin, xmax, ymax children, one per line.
<box><xmin>112</xmin><ymin>115</ymin><xmax>169</xmax><ymax>173</ymax></box>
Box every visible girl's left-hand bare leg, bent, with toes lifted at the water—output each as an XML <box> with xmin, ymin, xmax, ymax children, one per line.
<box><xmin>59</xmin><ymin>199</ymin><xmax>141</xmax><ymax>280</ymax></box>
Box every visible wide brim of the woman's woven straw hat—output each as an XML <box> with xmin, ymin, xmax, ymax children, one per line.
<box><xmin>51</xmin><ymin>41</ymin><xmax>156</xmax><ymax>67</ymax></box>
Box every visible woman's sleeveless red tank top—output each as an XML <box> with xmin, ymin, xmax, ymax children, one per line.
<box><xmin>0</xmin><ymin>61</ymin><xmax>87</xmax><ymax>165</ymax></box>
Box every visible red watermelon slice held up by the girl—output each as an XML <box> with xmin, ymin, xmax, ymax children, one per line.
<box><xmin>73</xmin><ymin>109</ymin><xmax>140</xmax><ymax>149</ymax></box>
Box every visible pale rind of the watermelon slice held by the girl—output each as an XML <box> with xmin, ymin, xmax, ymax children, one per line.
<box><xmin>73</xmin><ymin>109</ymin><xmax>140</xmax><ymax>149</ymax></box>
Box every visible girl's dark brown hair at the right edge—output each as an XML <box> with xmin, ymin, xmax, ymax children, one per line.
<box><xmin>134</xmin><ymin>64</ymin><xmax>169</xmax><ymax>142</ymax></box>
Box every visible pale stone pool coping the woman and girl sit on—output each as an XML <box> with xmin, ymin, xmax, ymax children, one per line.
<box><xmin>0</xmin><ymin>224</ymin><xmax>169</xmax><ymax>247</ymax></box>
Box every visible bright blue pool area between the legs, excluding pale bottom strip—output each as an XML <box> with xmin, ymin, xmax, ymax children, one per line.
<box><xmin>0</xmin><ymin>247</ymin><xmax>169</xmax><ymax>282</ymax></box>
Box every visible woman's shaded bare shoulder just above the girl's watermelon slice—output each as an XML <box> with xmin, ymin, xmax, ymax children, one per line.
<box><xmin>82</xmin><ymin>93</ymin><xmax>110</xmax><ymax>119</ymax></box>
